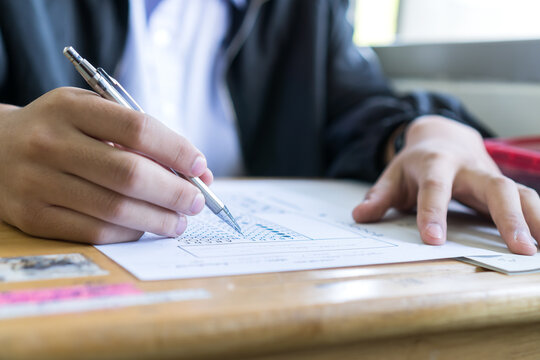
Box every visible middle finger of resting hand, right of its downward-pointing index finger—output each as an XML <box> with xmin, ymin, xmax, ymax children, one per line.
<box><xmin>483</xmin><ymin>176</ymin><xmax>537</xmax><ymax>255</ymax></box>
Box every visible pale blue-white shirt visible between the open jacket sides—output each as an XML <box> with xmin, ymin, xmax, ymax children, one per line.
<box><xmin>116</xmin><ymin>0</ymin><xmax>247</xmax><ymax>176</ymax></box>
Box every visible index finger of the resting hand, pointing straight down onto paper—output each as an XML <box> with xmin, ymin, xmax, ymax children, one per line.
<box><xmin>416</xmin><ymin>172</ymin><xmax>454</xmax><ymax>245</ymax></box>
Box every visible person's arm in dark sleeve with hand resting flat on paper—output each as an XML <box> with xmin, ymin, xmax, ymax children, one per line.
<box><xmin>327</xmin><ymin>2</ymin><xmax>540</xmax><ymax>254</ymax></box>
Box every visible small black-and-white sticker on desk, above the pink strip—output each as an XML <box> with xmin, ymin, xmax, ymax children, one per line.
<box><xmin>0</xmin><ymin>254</ymin><xmax>108</xmax><ymax>282</ymax></box>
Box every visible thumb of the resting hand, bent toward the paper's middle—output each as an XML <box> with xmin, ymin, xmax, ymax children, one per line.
<box><xmin>352</xmin><ymin>166</ymin><xmax>401</xmax><ymax>223</ymax></box>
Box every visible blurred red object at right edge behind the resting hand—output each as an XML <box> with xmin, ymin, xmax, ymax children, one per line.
<box><xmin>484</xmin><ymin>137</ymin><xmax>540</xmax><ymax>193</ymax></box>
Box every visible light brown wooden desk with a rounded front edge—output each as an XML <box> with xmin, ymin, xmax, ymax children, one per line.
<box><xmin>0</xmin><ymin>224</ymin><xmax>540</xmax><ymax>359</ymax></box>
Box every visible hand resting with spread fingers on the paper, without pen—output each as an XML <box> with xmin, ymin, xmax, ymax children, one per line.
<box><xmin>353</xmin><ymin>116</ymin><xmax>540</xmax><ymax>255</ymax></box>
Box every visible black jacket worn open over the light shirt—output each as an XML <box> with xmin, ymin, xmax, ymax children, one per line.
<box><xmin>0</xmin><ymin>0</ymin><xmax>492</xmax><ymax>180</ymax></box>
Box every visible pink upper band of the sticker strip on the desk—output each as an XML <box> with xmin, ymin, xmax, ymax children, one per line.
<box><xmin>0</xmin><ymin>283</ymin><xmax>142</xmax><ymax>306</ymax></box>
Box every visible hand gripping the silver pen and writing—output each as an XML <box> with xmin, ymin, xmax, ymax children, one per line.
<box><xmin>0</xmin><ymin>88</ymin><xmax>212</xmax><ymax>244</ymax></box>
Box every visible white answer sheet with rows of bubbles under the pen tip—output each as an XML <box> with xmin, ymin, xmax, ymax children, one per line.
<box><xmin>96</xmin><ymin>180</ymin><xmax>540</xmax><ymax>280</ymax></box>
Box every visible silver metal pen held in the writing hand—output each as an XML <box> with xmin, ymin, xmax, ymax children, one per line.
<box><xmin>64</xmin><ymin>46</ymin><xmax>243</xmax><ymax>235</ymax></box>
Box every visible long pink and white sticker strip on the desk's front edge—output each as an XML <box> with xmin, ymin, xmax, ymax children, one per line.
<box><xmin>0</xmin><ymin>284</ymin><xmax>210</xmax><ymax>320</ymax></box>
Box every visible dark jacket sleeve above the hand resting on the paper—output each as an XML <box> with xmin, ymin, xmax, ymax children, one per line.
<box><xmin>324</xmin><ymin>0</ymin><xmax>490</xmax><ymax>181</ymax></box>
